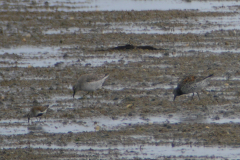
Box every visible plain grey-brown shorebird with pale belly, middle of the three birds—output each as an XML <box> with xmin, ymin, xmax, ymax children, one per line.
<box><xmin>73</xmin><ymin>74</ymin><xmax>109</xmax><ymax>98</ymax></box>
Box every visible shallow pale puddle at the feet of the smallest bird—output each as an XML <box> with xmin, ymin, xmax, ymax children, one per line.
<box><xmin>0</xmin><ymin>117</ymin><xmax>176</xmax><ymax>134</ymax></box>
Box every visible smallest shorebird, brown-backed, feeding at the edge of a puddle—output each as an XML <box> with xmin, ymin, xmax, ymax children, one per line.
<box><xmin>24</xmin><ymin>105</ymin><xmax>49</xmax><ymax>123</ymax></box>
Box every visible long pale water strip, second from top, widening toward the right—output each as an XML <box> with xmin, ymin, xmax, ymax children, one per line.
<box><xmin>43</xmin><ymin>13</ymin><xmax>240</xmax><ymax>35</ymax></box>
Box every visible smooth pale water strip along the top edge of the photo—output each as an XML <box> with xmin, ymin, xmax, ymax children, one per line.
<box><xmin>80</xmin><ymin>0</ymin><xmax>239</xmax><ymax>11</ymax></box>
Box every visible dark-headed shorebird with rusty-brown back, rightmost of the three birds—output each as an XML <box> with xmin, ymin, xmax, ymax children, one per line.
<box><xmin>173</xmin><ymin>74</ymin><xmax>213</xmax><ymax>101</ymax></box>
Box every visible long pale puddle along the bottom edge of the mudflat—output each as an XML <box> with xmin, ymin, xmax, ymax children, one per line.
<box><xmin>1</xmin><ymin>144</ymin><xmax>240</xmax><ymax>159</ymax></box>
